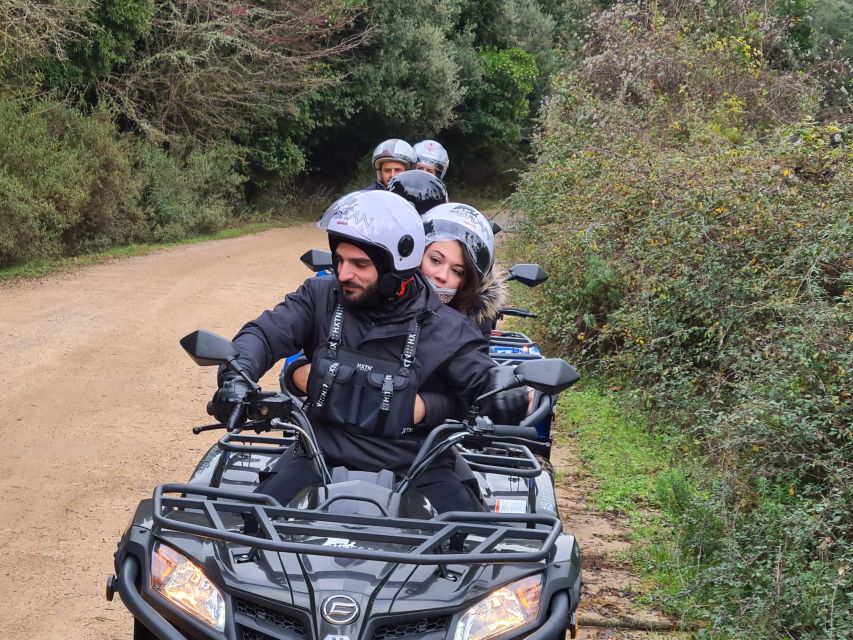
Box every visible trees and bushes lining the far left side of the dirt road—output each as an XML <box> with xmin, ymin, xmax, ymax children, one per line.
<box><xmin>0</xmin><ymin>0</ymin><xmax>564</xmax><ymax>265</ymax></box>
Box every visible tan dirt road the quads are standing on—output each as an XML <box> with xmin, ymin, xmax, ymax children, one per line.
<box><xmin>0</xmin><ymin>225</ymin><xmax>680</xmax><ymax>640</ymax></box>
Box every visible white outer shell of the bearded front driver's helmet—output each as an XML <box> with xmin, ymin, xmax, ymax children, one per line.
<box><xmin>317</xmin><ymin>191</ymin><xmax>424</xmax><ymax>277</ymax></box>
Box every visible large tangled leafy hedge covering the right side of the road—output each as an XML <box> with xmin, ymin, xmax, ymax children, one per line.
<box><xmin>513</xmin><ymin>2</ymin><xmax>853</xmax><ymax>639</ymax></box>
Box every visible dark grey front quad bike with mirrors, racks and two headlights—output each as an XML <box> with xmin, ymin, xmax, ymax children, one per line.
<box><xmin>107</xmin><ymin>331</ymin><xmax>581</xmax><ymax>640</ymax></box>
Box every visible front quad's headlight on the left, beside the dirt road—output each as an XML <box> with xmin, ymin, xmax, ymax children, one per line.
<box><xmin>151</xmin><ymin>542</ymin><xmax>225</xmax><ymax>631</ymax></box>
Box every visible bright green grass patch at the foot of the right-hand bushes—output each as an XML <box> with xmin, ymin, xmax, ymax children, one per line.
<box><xmin>557</xmin><ymin>384</ymin><xmax>684</xmax><ymax>609</ymax></box>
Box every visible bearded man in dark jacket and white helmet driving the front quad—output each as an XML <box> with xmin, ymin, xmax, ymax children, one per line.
<box><xmin>213</xmin><ymin>191</ymin><xmax>527</xmax><ymax>512</ymax></box>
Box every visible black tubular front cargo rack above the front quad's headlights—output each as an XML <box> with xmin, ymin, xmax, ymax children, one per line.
<box><xmin>154</xmin><ymin>483</ymin><xmax>562</xmax><ymax>565</ymax></box>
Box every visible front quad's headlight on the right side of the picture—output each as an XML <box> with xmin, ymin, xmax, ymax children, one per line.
<box><xmin>454</xmin><ymin>575</ymin><xmax>542</xmax><ymax>640</ymax></box>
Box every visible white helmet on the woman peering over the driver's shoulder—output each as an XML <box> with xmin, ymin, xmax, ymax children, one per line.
<box><xmin>421</xmin><ymin>202</ymin><xmax>495</xmax><ymax>278</ymax></box>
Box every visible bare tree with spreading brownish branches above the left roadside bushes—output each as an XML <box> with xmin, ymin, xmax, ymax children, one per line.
<box><xmin>99</xmin><ymin>0</ymin><xmax>370</xmax><ymax>138</ymax></box>
